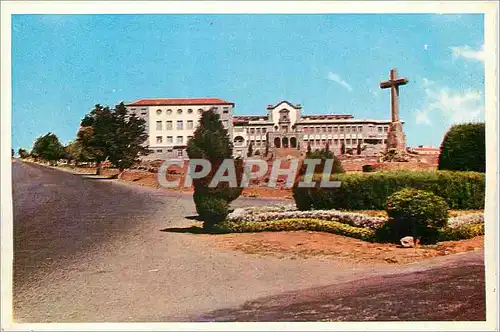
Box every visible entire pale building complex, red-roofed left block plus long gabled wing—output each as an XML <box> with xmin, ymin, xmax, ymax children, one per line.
<box><xmin>126</xmin><ymin>98</ymin><xmax>391</xmax><ymax>159</ymax></box>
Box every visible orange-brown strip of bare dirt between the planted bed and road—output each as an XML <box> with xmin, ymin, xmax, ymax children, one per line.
<box><xmin>204</xmin><ymin>231</ymin><xmax>484</xmax><ymax>265</ymax></box>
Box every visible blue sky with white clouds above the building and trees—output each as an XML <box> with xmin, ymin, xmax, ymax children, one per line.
<box><xmin>12</xmin><ymin>14</ymin><xmax>484</xmax><ymax>150</ymax></box>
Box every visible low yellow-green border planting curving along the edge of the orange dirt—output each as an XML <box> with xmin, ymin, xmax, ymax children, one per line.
<box><xmin>212</xmin><ymin>219</ymin><xmax>375</xmax><ymax>242</ymax></box>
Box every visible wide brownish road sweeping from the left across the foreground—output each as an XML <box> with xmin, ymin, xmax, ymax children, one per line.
<box><xmin>13</xmin><ymin>161</ymin><xmax>484</xmax><ymax>322</ymax></box>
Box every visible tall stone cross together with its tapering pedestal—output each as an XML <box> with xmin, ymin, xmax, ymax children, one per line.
<box><xmin>380</xmin><ymin>69</ymin><xmax>408</xmax><ymax>153</ymax></box>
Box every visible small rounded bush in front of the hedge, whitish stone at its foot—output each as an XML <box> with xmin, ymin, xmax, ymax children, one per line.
<box><xmin>385</xmin><ymin>188</ymin><xmax>448</xmax><ymax>243</ymax></box>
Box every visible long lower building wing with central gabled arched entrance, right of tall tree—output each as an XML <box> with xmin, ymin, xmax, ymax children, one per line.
<box><xmin>233</xmin><ymin>101</ymin><xmax>391</xmax><ymax>156</ymax></box>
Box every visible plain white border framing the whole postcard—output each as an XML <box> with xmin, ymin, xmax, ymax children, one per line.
<box><xmin>0</xmin><ymin>1</ymin><xmax>498</xmax><ymax>331</ymax></box>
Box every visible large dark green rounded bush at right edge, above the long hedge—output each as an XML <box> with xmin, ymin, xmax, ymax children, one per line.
<box><xmin>438</xmin><ymin>123</ymin><xmax>486</xmax><ymax>172</ymax></box>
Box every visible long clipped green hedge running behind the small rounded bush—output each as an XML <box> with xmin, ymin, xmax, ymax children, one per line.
<box><xmin>293</xmin><ymin>171</ymin><xmax>485</xmax><ymax>210</ymax></box>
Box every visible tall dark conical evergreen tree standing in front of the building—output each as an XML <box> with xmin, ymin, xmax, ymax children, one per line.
<box><xmin>187</xmin><ymin>109</ymin><xmax>243</xmax><ymax>229</ymax></box>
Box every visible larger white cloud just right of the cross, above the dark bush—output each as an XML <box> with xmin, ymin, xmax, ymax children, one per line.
<box><xmin>415</xmin><ymin>78</ymin><xmax>484</xmax><ymax>125</ymax></box>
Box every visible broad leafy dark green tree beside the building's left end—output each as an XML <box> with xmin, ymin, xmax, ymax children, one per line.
<box><xmin>77</xmin><ymin>102</ymin><xmax>151</xmax><ymax>174</ymax></box>
